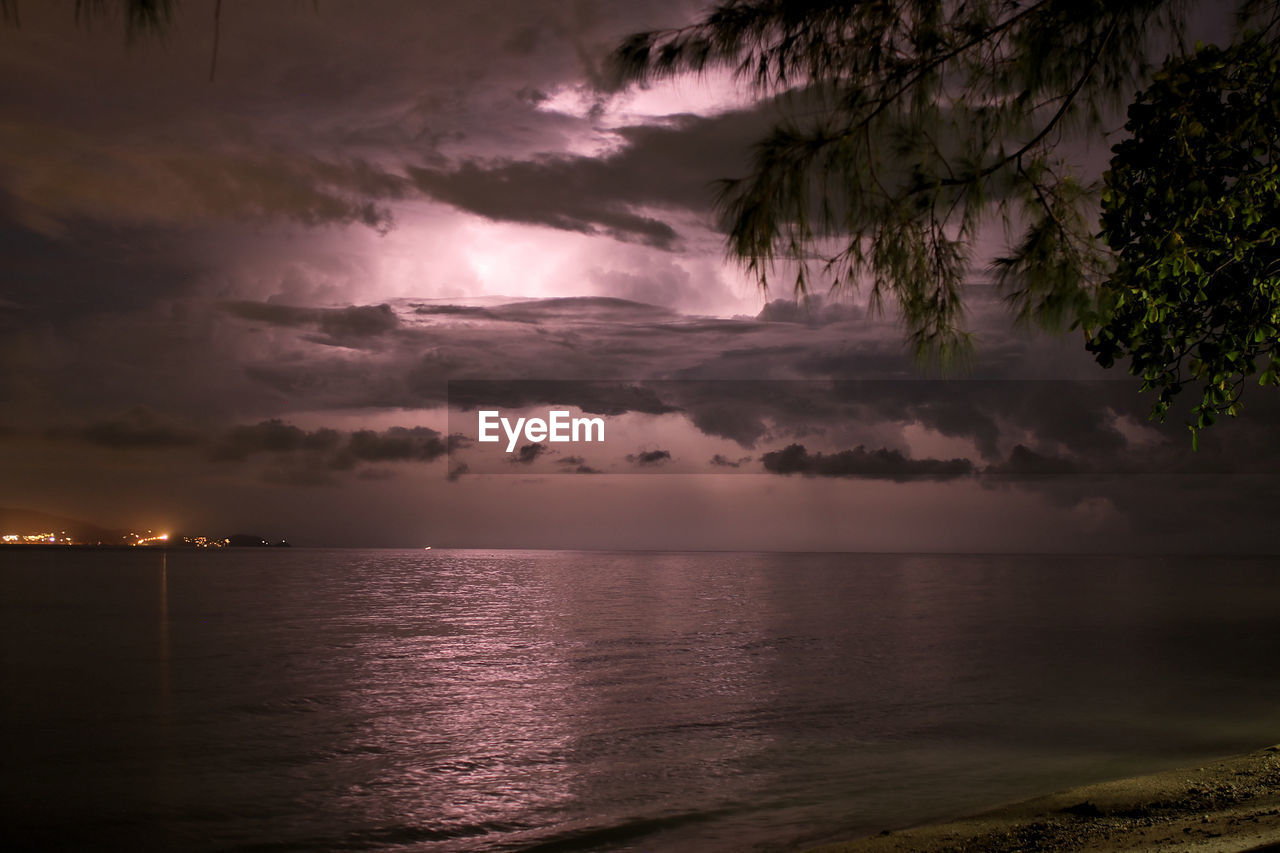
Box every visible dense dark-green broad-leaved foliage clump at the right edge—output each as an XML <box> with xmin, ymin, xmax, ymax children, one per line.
<box><xmin>1088</xmin><ymin>37</ymin><xmax>1280</xmax><ymax>433</ymax></box>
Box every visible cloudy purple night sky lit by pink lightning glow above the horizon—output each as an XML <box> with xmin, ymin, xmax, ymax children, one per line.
<box><xmin>0</xmin><ymin>0</ymin><xmax>1280</xmax><ymax>553</ymax></box>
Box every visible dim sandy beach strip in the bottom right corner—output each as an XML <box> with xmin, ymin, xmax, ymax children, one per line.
<box><xmin>812</xmin><ymin>745</ymin><xmax>1280</xmax><ymax>853</ymax></box>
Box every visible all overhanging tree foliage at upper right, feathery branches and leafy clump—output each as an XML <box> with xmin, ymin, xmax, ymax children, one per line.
<box><xmin>613</xmin><ymin>0</ymin><xmax>1280</xmax><ymax>438</ymax></box>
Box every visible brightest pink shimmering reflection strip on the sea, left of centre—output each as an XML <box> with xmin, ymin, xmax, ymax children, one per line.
<box><xmin>337</xmin><ymin>555</ymin><xmax>572</xmax><ymax>838</ymax></box>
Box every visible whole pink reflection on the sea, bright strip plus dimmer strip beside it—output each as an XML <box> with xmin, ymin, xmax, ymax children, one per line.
<box><xmin>333</xmin><ymin>553</ymin><xmax>778</xmax><ymax>848</ymax></box>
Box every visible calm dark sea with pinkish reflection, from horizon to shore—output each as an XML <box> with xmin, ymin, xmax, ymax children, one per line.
<box><xmin>0</xmin><ymin>549</ymin><xmax>1280</xmax><ymax>852</ymax></box>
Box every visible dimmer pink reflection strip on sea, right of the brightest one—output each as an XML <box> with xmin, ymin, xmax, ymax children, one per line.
<box><xmin>547</xmin><ymin>553</ymin><xmax>777</xmax><ymax>824</ymax></box>
